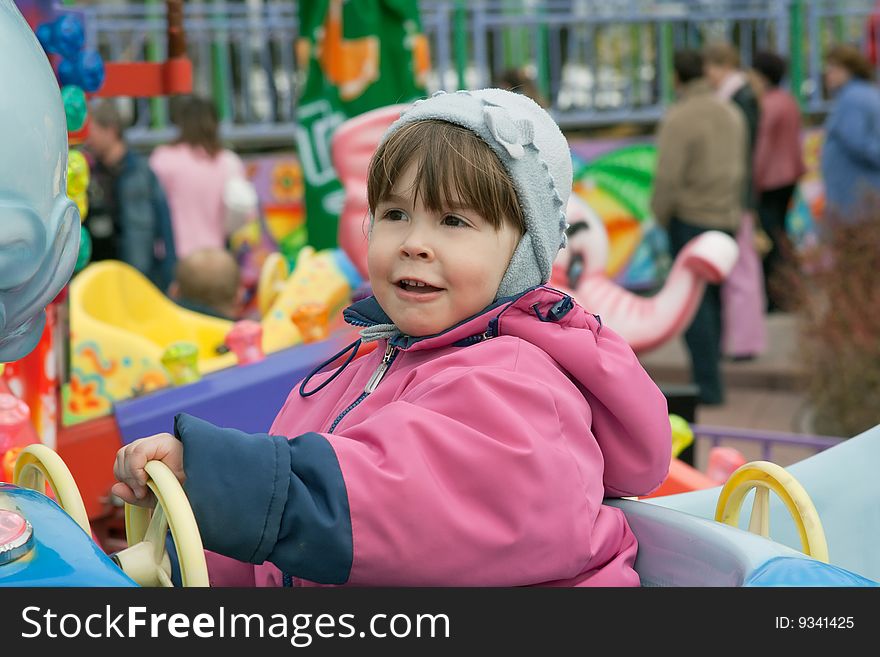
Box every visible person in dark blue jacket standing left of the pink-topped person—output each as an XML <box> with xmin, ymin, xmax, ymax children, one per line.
<box><xmin>83</xmin><ymin>99</ymin><xmax>176</xmax><ymax>292</ymax></box>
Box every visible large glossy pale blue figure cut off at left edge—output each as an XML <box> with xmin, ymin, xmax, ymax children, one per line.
<box><xmin>0</xmin><ymin>0</ymin><xmax>80</xmax><ymax>362</ymax></box>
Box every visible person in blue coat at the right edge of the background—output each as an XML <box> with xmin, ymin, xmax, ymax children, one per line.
<box><xmin>822</xmin><ymin>45</ymin><xmax>880</xmax><ymax>223</ymax></box>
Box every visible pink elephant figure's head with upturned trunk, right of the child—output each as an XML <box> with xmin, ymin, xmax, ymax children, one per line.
<box><xmin>550</xmin><ymin>194</ymin><xmax>739</xmax><ymax>353</ymax></box>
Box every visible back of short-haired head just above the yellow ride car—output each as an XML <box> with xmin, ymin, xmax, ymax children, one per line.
<box><xmin>168</xmin><ymin>247</ymin><xmax>244</xmax><ymax>320</ymax></box>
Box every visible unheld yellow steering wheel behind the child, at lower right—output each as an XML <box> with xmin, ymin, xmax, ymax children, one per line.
<box><xmin>715</xmin><ymin>461</ymin><xmax>828</xmax><ymax>563</ymax></box>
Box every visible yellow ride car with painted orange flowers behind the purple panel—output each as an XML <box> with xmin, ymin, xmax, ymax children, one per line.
<box><xmin>62</xmin><ymin>247</ymin><xmax>361</xmax><ymax>425</ymax></box>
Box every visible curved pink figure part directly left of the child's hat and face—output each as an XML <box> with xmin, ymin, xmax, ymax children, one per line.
<box><xmin>330</xmin><ymin>104</ymin><xmax>409</xmax><ymax>280</ymax></box>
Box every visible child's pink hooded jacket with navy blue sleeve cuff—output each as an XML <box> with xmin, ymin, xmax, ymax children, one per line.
<box><xmin>178</xmin><ymin>287</ymin><xmax>671</xmax><ymax>586</ymax></box>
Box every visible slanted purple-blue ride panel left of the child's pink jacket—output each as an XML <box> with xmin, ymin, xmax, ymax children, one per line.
<box><xmin>114</xmin><ymin>330</ymin><xmax>358</xmax><ymax>445</ymax></box>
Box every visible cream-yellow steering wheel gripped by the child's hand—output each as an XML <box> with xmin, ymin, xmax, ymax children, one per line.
<box><xmin>113</xmin><ymin>461</ymin><xmax>209</xmax><ymax>586</ymax></box>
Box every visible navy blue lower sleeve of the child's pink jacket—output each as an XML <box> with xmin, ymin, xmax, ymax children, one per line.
<box><xmin>174</xmin><ymin>413</ymin><xmax>354</xmax><ymax>584</ymax></box>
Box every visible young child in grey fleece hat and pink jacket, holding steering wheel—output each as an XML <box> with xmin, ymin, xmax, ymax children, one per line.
<box><xmin>113</xmin><ymin>89</ymin><xmax>671</xmax><ymax>586</ymax></box>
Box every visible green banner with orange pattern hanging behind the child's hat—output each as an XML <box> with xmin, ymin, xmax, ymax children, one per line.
<box><xmin>296</xmin><ymin>0</ymin><xmax>428</xmax><ymax>249</ymax></box>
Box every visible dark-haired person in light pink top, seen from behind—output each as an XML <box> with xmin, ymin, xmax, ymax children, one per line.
<box><xmin>150</xmin><ymin>96</ymin><xmax>245</xmax><ymax>258</ymax></box>
